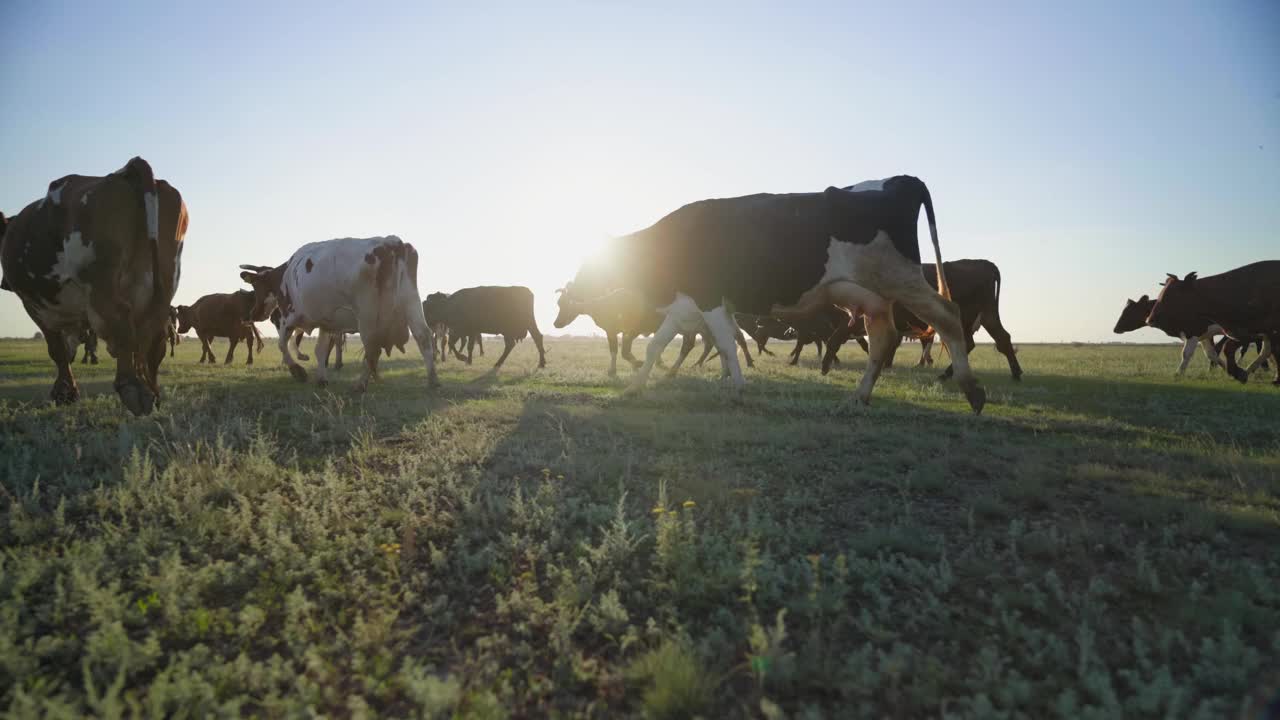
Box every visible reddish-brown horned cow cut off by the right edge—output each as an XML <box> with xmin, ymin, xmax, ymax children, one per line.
<box><xmin>1147</xmin><ymin>260</ymin><xmax>1280</xmax><ymax>386</ymax></box>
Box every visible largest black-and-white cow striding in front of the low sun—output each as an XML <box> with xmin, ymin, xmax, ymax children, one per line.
<box><xmin>576</xmin><ymin>176</ymin><xmax>986</xmax><ymax>413</ymax></box>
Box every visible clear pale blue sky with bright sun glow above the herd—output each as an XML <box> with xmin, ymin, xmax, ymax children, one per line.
<box><xmin>0</xmin><ymin>0</ymin><xmax>1280</xmax><ymax>342</ymax></box>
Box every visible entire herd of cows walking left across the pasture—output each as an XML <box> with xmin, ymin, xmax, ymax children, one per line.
<box><xmin>0</xmin><ymin>158</ymin><xmax>1280</xmax><ymax>415</ymax></box>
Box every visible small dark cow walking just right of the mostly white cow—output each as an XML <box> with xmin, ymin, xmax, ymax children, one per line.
<box><xmin>422</xmin><ymin>286</ymin><xmax>547</xmax><ymax>370</ymax></box>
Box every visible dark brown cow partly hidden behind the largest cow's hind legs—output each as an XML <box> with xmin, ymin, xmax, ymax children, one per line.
<box><xmin>822</xmin><ymin>260</ymin><xmax>1023</xmax><ymax>380</ymax></box>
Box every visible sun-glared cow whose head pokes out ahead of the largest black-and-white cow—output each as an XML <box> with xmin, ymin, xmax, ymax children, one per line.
<box><xmin>554</xmin><ymin>284</ymin><xmax>755</xmax><ymax>378</ymax></box>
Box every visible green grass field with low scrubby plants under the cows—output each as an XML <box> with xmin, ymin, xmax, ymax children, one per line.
<box><xmin>0</xmin><ymin>338</ymin><xmax>1280</xmax><ymax>717</ymax></box>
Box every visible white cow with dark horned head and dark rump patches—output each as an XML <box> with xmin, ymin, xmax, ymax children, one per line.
<box><xmin>241</xmin><ymin>236</ymin><xmax>439</xmax><ymax>392</ymax></box>
